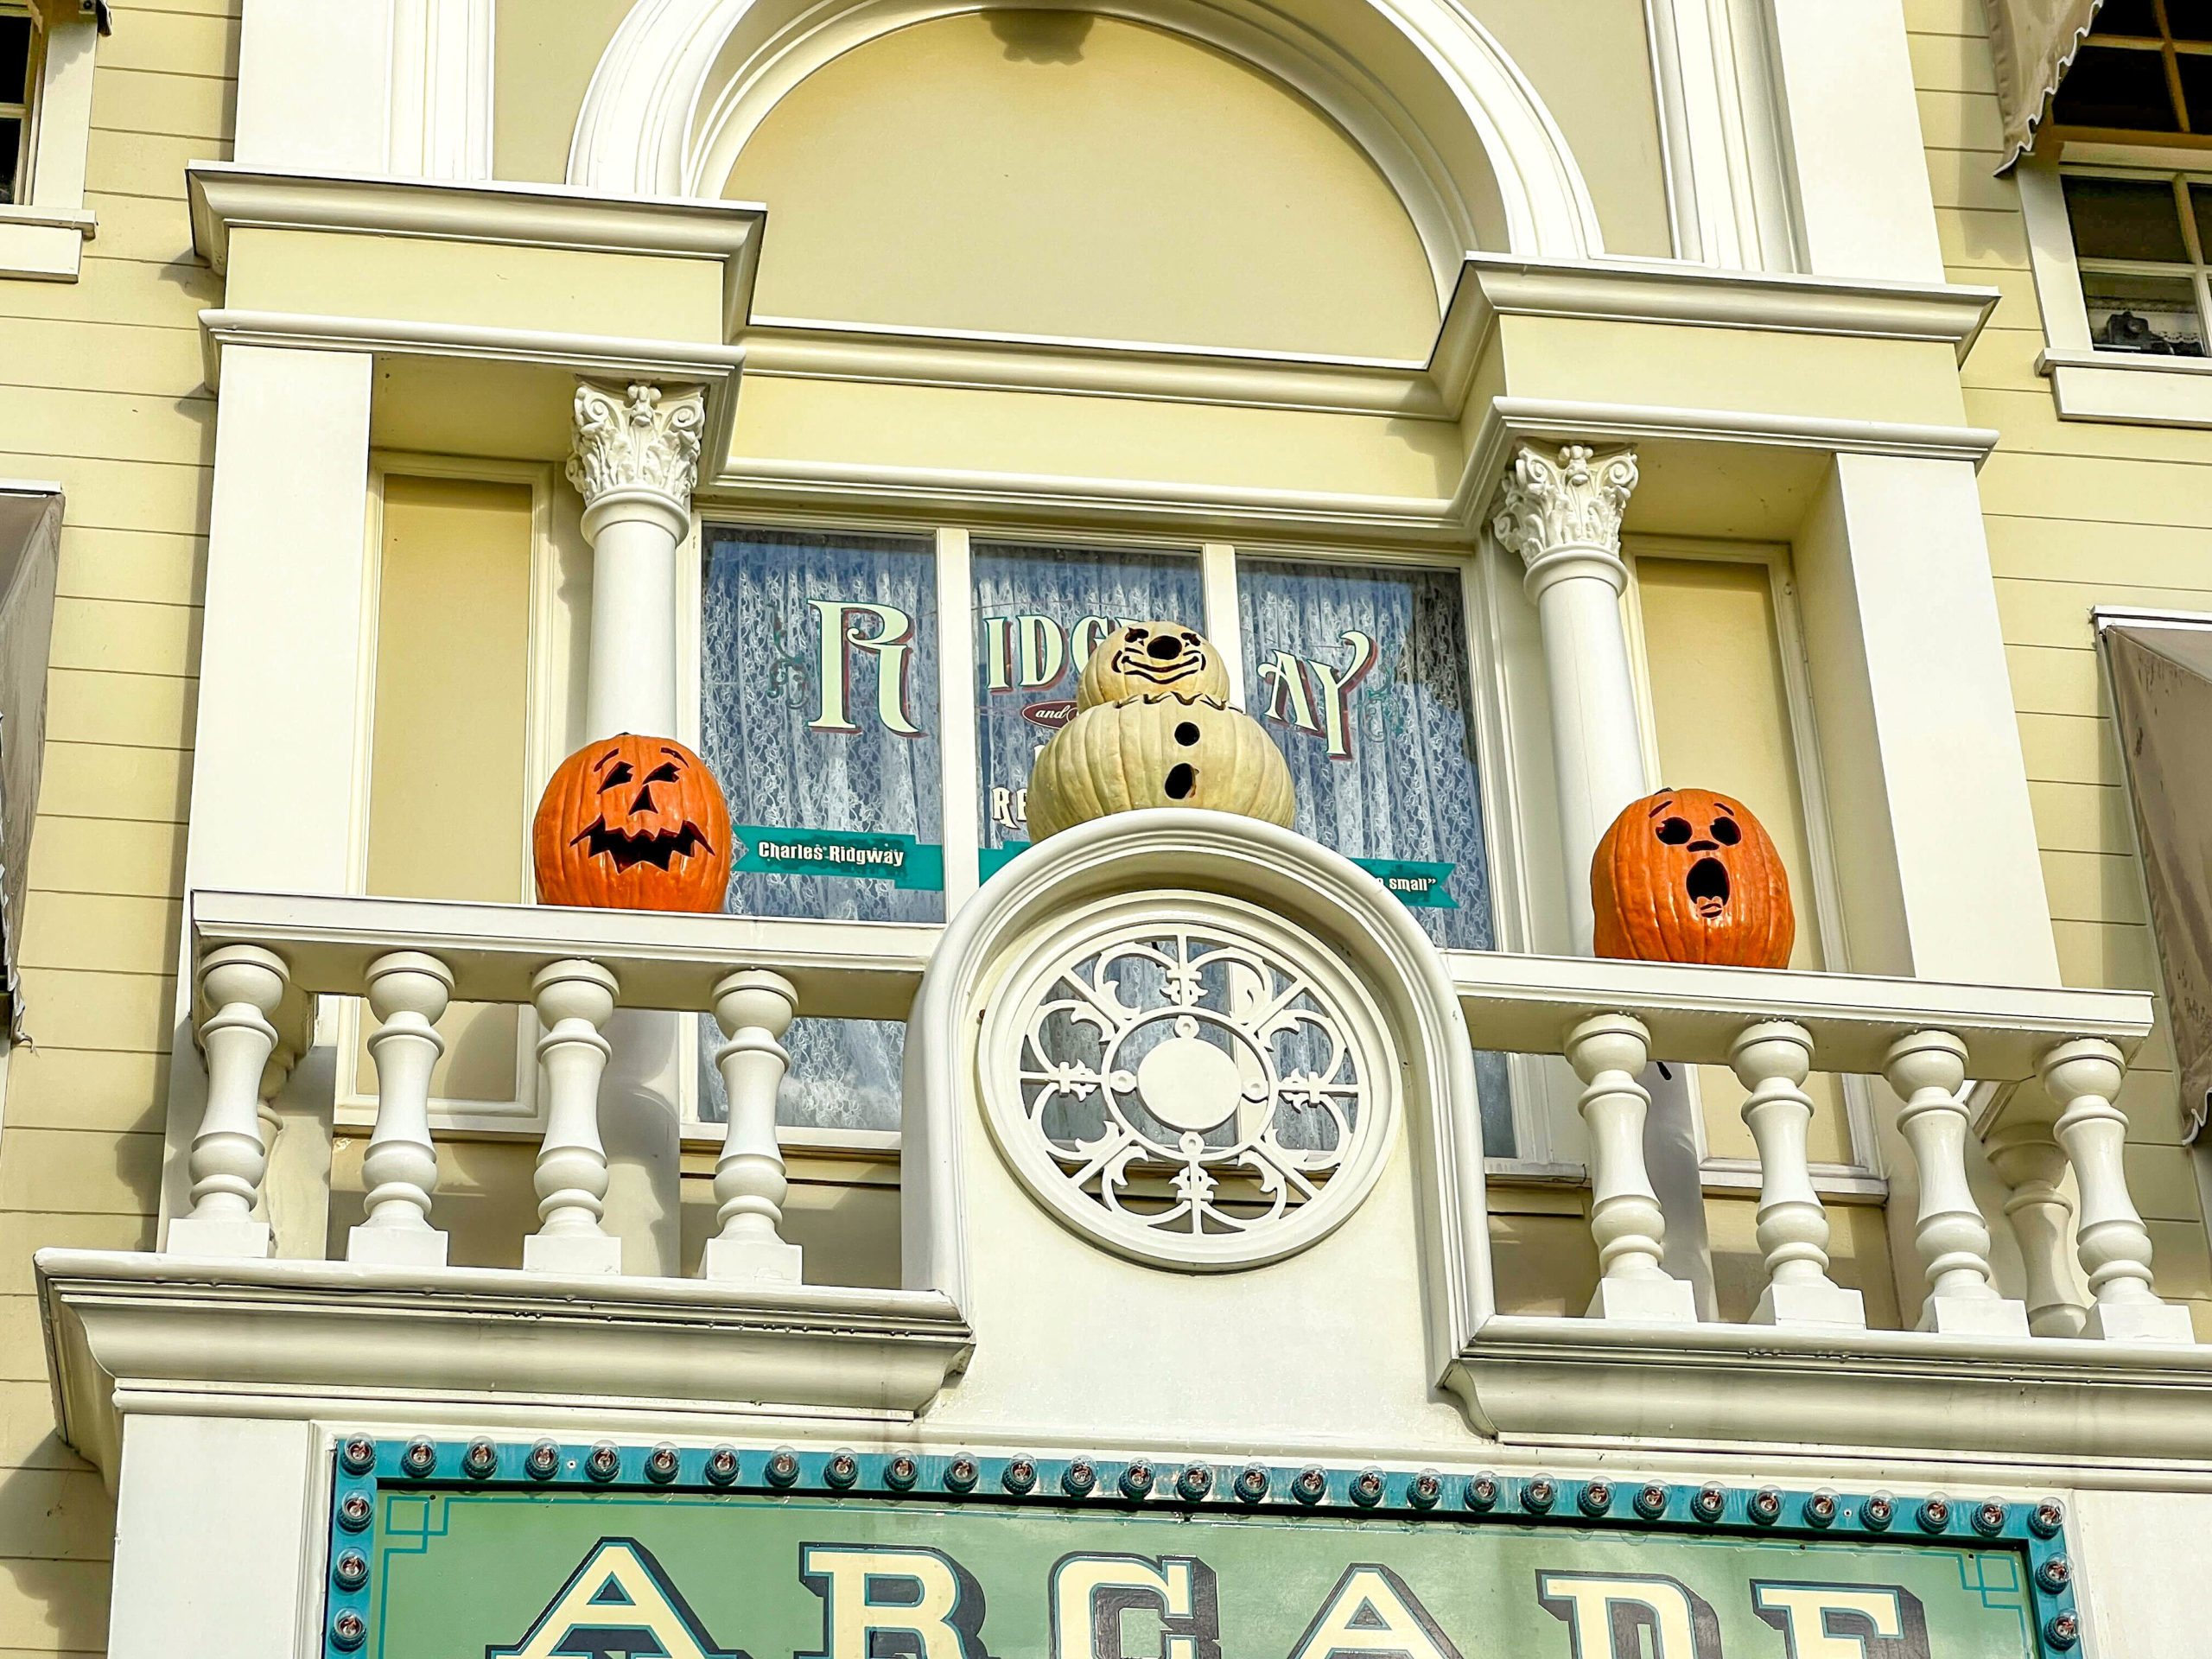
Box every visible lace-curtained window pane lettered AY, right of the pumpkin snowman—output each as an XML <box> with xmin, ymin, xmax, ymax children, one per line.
<box><xmin>1236</xmin><ymin>560</ymin><xmax>1491</xmax><ymax>951</ymax></box>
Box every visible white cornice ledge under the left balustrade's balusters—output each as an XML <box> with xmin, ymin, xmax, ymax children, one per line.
<box><xmin>35</xmin><ymin>1249</ymin><xmax>976</xmax><ymax>1482</ymax></box>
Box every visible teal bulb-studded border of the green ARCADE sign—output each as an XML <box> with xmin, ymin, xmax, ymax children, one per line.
<box><xmin>323</xmin><ymin>1435</ymin><xmax>2082</xmax><ymax>1659</ymax></box>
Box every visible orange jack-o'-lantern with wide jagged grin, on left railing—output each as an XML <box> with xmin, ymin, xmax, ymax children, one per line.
<box><xmin>531</xmin><ymin>732</ymin><xmax>730</xmax><ymax>909</ymax></box>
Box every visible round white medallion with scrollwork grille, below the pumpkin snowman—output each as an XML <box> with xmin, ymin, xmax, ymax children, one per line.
<box><xmin>980</xmin><ymin>892</ymin><xmax>1398</xmax><ymax>1269</ymax></box>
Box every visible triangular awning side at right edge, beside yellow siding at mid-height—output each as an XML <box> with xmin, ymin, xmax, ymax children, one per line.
<box><xmin>2101</xmin><ymin>617</ymin><xmax>2212</xmax><ymax>1139</ymax></box>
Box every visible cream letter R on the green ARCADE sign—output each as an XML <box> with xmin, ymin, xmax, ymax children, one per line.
<box><xmin>798</xmin><ymin>1544</ymin><xmax>987</xmax><ymax>1659</ymax></box>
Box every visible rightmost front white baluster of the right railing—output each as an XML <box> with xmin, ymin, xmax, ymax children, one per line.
<box><xmin>2042</xmin><ymin>1038</ymin><xmax>2195</xmax><ymax>1343</ymax></box>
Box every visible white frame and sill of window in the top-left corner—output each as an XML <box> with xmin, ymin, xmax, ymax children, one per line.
<box><xmin>0</xmin><ymin>0</ymin><xmax>99</xmax><ymax>283</ymax></box>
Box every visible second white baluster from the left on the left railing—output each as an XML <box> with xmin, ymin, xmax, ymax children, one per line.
<box><xmin>345</xmin><ymin>951</ymin><xmax>454</xmax><ymax>1268</ymax></box>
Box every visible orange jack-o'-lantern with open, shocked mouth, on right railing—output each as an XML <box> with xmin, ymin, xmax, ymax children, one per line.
<box><xmin>1591</xmin><ymin>790</ymin><xmax>1796</xmax><ymax>967</ymax></box>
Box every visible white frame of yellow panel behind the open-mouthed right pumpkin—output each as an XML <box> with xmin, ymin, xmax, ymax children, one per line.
<box><xmin>1621</xmin><ymin>536</ymin><xmax>1889</xmax><ymax>1204</ymax></box>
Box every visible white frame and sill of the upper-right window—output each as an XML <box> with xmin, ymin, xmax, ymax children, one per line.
<box><xmin>2013</xmin><ymin>150</ymin><xmax>2212</xmax><ymax>427</ymax></box>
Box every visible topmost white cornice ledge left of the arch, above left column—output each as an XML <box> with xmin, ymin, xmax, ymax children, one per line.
<box><xmin>183</xmin><ymin>162</ymin><xmax>767</xmax><ymax>339</ymax></box>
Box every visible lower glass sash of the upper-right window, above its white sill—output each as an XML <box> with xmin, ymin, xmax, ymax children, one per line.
<box><xmin>2062</xmin><ymin>172</ymin><xmax>2212</xmax><ymax>356</ymax></box>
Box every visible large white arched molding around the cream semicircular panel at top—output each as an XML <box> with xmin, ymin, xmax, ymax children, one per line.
<box><xmin>569</xmin><ymin>0</ymin><xmax>1604</xmax><ymax>277</ymax></box>
